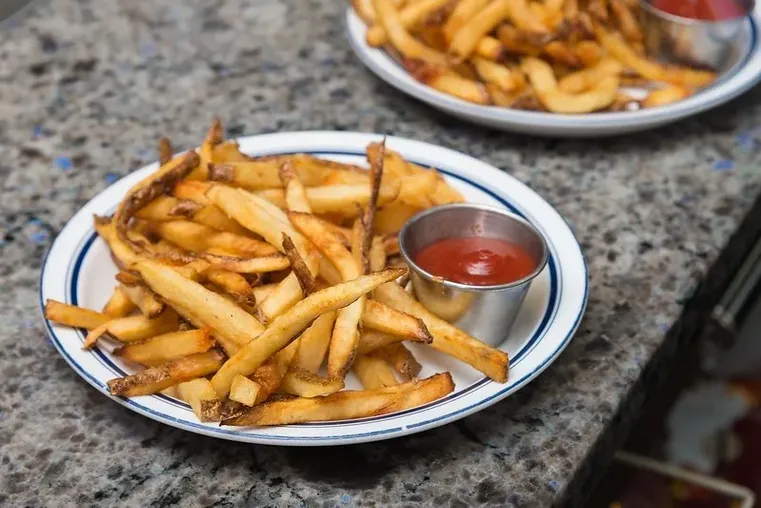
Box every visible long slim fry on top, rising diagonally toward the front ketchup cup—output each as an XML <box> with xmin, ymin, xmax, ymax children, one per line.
<box><xmin>211</xmin><ymin>269</ymin><xmax>406</xmax><ymax>397</ymax></box>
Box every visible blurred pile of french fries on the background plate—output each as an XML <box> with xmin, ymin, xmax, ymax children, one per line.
<box><xmin>352</xmin><ymin>0</ymin><xmax>716</xmax><ymax>114</ymax></box>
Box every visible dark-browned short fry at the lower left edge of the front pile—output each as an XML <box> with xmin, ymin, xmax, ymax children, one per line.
<box><xmin>107</xmin><ymin>349</ymin><xmax>226</xmax><ymax>397</ymax></box>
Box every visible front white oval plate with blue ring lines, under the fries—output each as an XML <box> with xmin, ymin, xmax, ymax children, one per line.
<box><xmin>40</xmin><ymin>132</ymin><xmax>588</xmax><ymax>446</ymax></box>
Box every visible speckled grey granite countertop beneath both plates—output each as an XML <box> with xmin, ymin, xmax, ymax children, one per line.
<box><xmin>0</xmin><ymin>0</ymin><xmax>761</xmax><ymax>507</ymax></box>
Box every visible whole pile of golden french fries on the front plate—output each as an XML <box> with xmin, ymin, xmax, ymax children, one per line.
<box><xmin>45</xmin><ymin>121</ymin><xmax>508</xmax><ymax>426</ymax></box>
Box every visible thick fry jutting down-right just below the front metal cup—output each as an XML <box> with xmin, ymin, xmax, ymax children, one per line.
<box><xmin>375</xmin><ymin>284</ymin><xmax>508</xmax><ymax>383</ymax></box>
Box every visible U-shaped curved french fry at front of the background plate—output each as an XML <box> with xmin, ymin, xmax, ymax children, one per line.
<box><xmin>521</xmin><ymin>57</ymin><xmax>618</xmax><ymax>114</ymax></box>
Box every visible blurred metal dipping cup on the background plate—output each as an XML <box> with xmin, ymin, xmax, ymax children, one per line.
<box><xmin>640</xmin><ymin>0</ymin><xmax>755</xmax><ymax>72</ymax></box>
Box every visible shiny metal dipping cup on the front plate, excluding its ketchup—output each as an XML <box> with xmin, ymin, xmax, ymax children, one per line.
<box><xmin>399</xmin><ymin>203</ymin><xmax>547</xmax><ymax>346</ymax></box>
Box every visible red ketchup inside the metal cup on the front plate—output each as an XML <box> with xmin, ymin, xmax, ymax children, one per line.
<box><xmin>415</xmin><ymin>237</ymin><xmax>536</xmax><ymax>286</ymax></box>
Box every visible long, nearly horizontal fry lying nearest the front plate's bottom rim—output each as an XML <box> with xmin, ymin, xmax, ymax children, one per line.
<box><xmin>222</xmin><ymin>374</ymin><xmax>453</xmax><ymax>426</ymax></box>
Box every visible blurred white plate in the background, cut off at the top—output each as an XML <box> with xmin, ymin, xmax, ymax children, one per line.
<box><xmin>346</xmin><ymin>6</ymin><xmax>761</xmax><ymax>137</ymax></box>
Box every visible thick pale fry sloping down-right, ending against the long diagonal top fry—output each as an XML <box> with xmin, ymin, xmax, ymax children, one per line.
<box><xmin>134</xmin><ymin>261</ymin><xmax>264</xmax><ymax>353</ymax></box>
